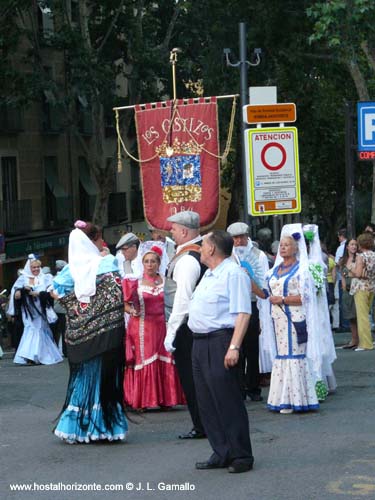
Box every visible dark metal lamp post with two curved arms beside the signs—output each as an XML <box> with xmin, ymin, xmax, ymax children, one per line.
<box><xmin>224</xmin><ymin>23</ymin><xmax>262</xmax><ymax>224</ymax></box>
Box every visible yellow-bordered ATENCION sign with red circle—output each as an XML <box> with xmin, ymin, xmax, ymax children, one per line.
<box><xmin>245</xmin><ymin>127</ymin><xmax>301</xmax><ymax>216</ymax></box>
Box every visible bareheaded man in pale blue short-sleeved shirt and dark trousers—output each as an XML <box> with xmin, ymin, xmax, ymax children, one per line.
<box><xmin>188</xmin><ymin>231</ymin><xmax>254</xmax><ymax>473</ymax></box>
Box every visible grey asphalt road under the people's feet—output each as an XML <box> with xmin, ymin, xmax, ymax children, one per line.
<box><xmin>0</xmin><ymin>334</ymin><xmax>375</xmax><ymax>500</ymax></box>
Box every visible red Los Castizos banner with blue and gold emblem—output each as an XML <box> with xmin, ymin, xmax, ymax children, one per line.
<box><xmin>135</xmin><ymin>97</ymin><xmax>220</xmax><ymax>230</ymax></box>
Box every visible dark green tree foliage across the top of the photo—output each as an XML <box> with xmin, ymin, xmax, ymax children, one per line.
<box><xmin>0</xmin><ymin>0</ymin><xmax>375</xmax><ymax>232</ymax></box>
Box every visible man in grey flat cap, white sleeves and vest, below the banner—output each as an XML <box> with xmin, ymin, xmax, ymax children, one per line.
<box><xmin>164</xmin><ymin>211</ymin><xmax>206</xmax><ymax>439</ymax></box>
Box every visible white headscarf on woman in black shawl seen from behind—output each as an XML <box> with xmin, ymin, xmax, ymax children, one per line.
<box><xmin>68</xmin><ymin>228</ymin><xmax>102</xmax><ymax>303</ymax></box>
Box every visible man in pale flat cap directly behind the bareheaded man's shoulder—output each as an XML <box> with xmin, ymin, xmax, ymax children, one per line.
<box><xmin>227</xmin><ymin>222</ymin><xmax>269</xmax><ymax>401</ymax></box>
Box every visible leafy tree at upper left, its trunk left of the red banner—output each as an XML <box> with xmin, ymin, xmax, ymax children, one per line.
<box><xmin>0</xmin><ymin>0</ymin><xmax>184</xmax><ymax>225</ymax></box>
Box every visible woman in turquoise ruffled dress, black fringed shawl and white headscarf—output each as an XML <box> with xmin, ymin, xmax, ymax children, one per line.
<box><xmin>53</xmin><ymin>221</ymin><xmax>128</xmax><ymax>443</ymax></box>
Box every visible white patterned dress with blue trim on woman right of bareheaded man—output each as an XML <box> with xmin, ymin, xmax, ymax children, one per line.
<box><xmin>267</xmin><ymin>262</ymin><xmax>319</xmax><ymax>412</ymax></box>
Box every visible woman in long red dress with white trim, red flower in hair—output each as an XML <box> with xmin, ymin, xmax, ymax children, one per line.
<box><xmin>122</xmin><ymin>246</ymin><xmax>185</xmax><ymax>410</ymax></box>
